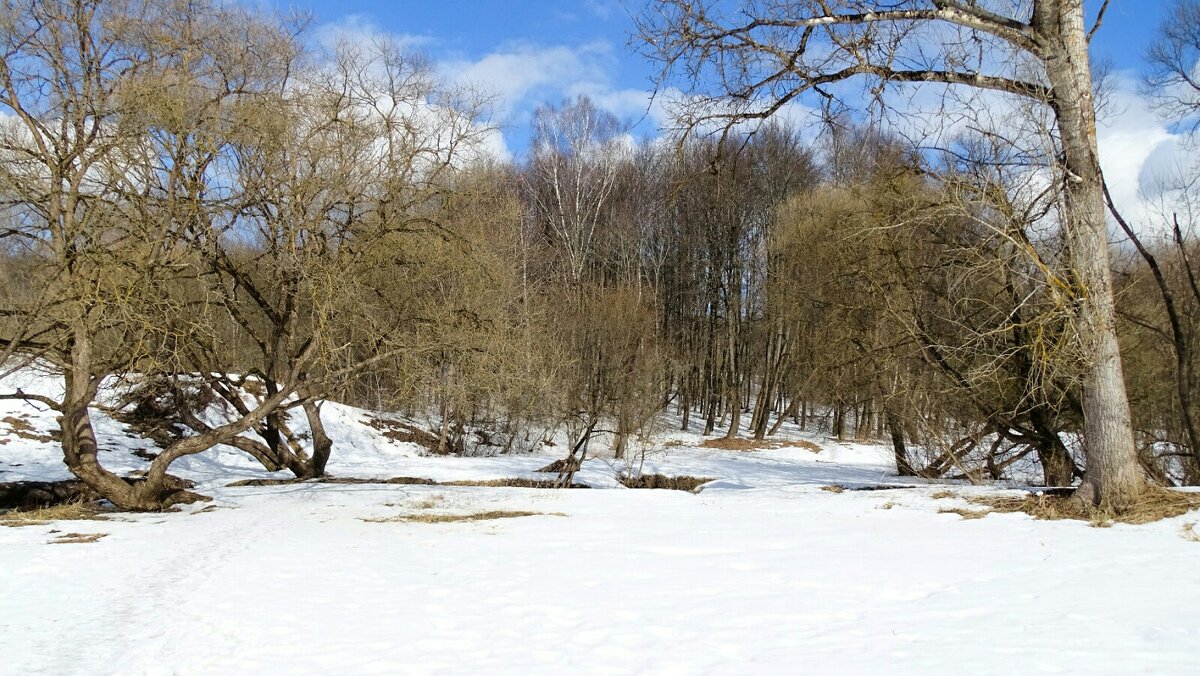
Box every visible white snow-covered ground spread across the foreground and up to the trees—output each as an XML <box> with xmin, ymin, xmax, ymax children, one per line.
<box><xmin>0</xmin><ymin>372</ymin><xmax>1200</xmax><ymax>675</ymax></box>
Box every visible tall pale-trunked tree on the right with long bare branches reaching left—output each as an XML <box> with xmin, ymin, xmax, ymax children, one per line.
<box><xmin>638</xmin><ymin>0</ymin><xmax>1144</xmax><ymax>510</ymax></box>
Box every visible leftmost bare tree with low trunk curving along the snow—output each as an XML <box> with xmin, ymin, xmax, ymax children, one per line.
<box><xmin>0</xmin><ymin>0</ymin><xmax>304</xmax><ymax>509</ymax></box>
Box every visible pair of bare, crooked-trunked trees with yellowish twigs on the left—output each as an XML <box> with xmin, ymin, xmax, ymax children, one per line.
<box><xmin>0</xmin><ymin>0</ymin><xmax>511</xmax><ymax>508</ymax></box>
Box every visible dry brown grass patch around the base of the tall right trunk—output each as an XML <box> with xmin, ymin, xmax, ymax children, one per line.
<box><xmin>967</xmin><ymin>487</ymin><xmax>1200</xmax><ymax>527</ymax></box>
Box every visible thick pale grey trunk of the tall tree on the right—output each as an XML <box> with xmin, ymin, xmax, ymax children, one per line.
<box><xmin>1034</xmin><ymin>0</ymin><xmax>1144</xmax><ymax>510</ymax></box>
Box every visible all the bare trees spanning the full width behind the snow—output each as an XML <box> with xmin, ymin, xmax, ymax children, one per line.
<box><xmin>0</xmin><ymin>0</ymin><xmax>1200</xmax><ymax>509</ymax></box>
